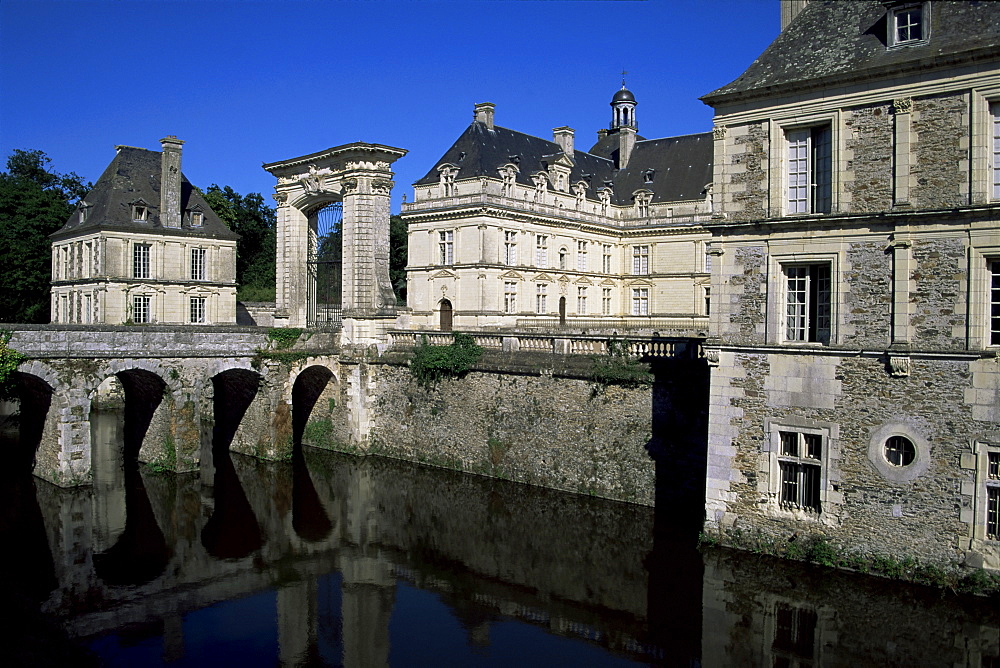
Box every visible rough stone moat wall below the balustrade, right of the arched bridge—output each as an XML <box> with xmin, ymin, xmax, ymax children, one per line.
<box><xmin>370</xmin><ymin>365</ymin><xmax>656</xmax><ymax>505</ymax></box>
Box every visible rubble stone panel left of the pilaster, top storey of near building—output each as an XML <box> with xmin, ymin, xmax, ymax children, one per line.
<box><xmin>844</xmin><ymin>104</ymin><xmax>893</xmax><ymax>213</ymax></box>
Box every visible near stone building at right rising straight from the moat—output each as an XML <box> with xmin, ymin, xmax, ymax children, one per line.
<box><xmin>704</xmin><ymin>2</ymin><xmax>1000</xmax><ymax>569</ymax></box>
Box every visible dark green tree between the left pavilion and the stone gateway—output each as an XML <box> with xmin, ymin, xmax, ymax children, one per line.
<box><xmin>205</xmin><ymin>183</ymin><xmax>277</xmax><ymax>301</ymax></box>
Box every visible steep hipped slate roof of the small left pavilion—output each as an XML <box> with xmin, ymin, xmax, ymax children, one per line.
<box><xmin>51</xmin><ymin>146</ymin><xmax>240</xmax><ymax>240</ymax></box>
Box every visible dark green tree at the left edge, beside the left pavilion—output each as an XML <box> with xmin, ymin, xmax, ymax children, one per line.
<box><xmin>0</xmin><ymin>149</ymin><xmax>93</xmax><ymax>322</ymax></box>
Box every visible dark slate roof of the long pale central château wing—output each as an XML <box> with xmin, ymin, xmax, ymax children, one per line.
<box><xmin>413</xmin><ymin>121</ymin><xmax>712</xmax><ymax>205</ymax></box>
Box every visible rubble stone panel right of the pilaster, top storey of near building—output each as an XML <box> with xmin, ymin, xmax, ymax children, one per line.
<box><xmin>910</xmin><ymin>95</ymin><xmax>969</xmax><ymax>209</ymax></box>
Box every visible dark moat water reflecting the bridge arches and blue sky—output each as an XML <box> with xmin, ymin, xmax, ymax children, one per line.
<box><xmin>0</xmin><ymin>412</ymin><xmax>1000</xmax><ymax>667</ymax></box>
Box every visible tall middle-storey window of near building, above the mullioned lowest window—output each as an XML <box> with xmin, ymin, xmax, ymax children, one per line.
<box><xmin>784</xmin><ymin>262</ymin><xmax>831</xmax><ymax>343</ymax></box>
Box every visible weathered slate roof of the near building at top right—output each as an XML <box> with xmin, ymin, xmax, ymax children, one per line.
<box><xmin>701</xmin><ymin>0</ymin><xmax>1000</xmax><ymax>105</ymax></box>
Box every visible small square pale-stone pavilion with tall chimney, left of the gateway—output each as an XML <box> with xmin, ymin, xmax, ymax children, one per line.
<box><xmin>52</xmin><ymin>137</ymin><xmax>239</xmax><ymax>325</ymax></box>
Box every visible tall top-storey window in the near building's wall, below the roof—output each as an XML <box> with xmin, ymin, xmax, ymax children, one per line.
<box><xmin>785</xmin><ymin>125</ymin><xmax>832</xmax><ymax>214</ymax></box>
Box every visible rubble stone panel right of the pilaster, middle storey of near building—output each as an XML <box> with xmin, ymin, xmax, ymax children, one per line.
<box><xmin>910</xmin><ymin>239</ymin><xmax>966</xmax><ymax>350</ymax></box>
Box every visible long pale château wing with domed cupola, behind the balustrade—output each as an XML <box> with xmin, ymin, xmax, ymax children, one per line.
<box><xmin>403</xmin><ymin>94</ymin><xmax>712</xmax><ymax>332</ymax></box>
